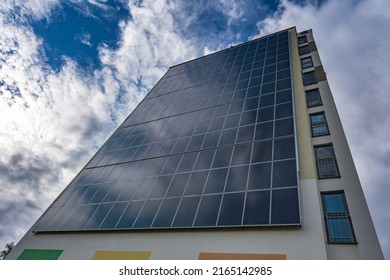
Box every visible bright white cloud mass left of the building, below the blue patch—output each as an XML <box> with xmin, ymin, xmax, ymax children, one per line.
<box><xmin>0</xmin><ymin>0</ymin><xmax>200</xmax><ymax>247</ymax></box>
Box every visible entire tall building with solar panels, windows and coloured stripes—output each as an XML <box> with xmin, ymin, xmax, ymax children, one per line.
<box><xmin>8</xmin><ymin>28</ymin><xmax>383</xmax><ymax>259</ymax></box>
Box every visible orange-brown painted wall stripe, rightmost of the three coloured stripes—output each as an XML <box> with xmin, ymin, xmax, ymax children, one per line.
<box><xmin>198</xmin><ymin>253</ymin><xmax>287</xmax><ymax>260</ymax></box>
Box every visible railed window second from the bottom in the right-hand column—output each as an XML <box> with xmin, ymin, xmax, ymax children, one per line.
<box><xmin>314</xmin><ymin>144</ymin><xmax>340</xmax><ymax>179</ymax></box>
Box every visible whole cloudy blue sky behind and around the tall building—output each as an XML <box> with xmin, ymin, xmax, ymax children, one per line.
<box><xmin>0</xmin><ymin>0</ymin><xmax>390</xmax><ymax>259</ymax></box>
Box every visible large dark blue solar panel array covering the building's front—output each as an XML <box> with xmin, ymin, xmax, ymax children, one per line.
<box><xmin>33</xmin><ymin>31</ymin><xmax>300</xmax><ymax>232</ymax></box>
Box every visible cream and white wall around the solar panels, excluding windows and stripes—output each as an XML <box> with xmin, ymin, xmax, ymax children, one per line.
<box><xmin>7</xmin><ymin>28</ymin><xmax>383</xmax><ymax>259</ymax></box>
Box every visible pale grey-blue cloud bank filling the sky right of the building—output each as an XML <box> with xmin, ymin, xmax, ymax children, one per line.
<box><xmin>258</xmin><ymin>0</ymin><xmax>390</xmax><ymax>258</ymax></box>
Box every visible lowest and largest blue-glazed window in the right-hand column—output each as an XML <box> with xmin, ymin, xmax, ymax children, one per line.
<box><xmin>321</xmin><ymin>192</ymin><xmax>356</xmax><ymax>243</ymax></box>
